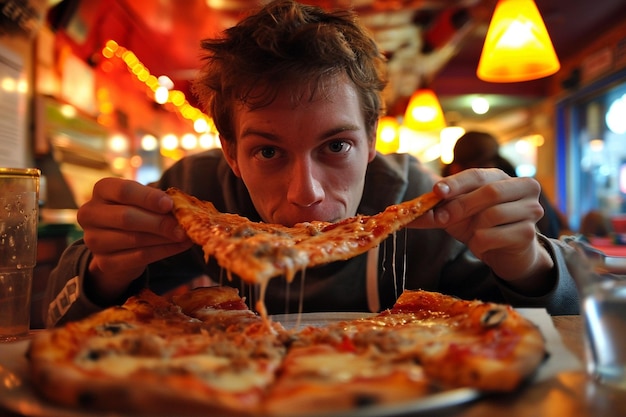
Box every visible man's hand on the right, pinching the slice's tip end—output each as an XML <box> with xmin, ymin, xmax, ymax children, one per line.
<box><xmin>410</xmin><ymin>168</ymin><xmax>554</xmax><ymax>294</ymax></box>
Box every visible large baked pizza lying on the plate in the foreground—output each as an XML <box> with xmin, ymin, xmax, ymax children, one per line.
<box><xmin>27</xmin><ymin>286</ymin><xmax>546</xmax><ymax>417</ymax></box>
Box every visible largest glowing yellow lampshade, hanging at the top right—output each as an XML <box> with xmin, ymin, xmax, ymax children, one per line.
<box><xmin>476</xmin><ymin>0</ymin><xmax>561</xmax><ymax>83</ymax></box>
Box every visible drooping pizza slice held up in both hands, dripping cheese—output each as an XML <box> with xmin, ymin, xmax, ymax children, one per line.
<box><xmin>167</xmin><ymin>188</ymin><xmax>440</xmax><ymax>283</ymax></box>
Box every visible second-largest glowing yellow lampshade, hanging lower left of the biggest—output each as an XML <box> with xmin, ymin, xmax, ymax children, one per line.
<box><xmin>404</xmin><ymin>88</ymin><xmax>446</xmax><ymax>131</ymax></box>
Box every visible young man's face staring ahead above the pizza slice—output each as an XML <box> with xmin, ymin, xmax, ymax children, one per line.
<box><xmin>223</xmin><ymin>77</ymin><xmax>375</xmax><ymax>226</ymax></box>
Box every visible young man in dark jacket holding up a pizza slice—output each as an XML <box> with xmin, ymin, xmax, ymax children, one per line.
<box><xmin>47</xmin><ymin>0</ymin><xmax>577</xmax><ymax>325</ymax></box>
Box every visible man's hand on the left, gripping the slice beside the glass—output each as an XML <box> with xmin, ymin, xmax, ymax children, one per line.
<box><xmin>77</xmin><ymin>178</ymin><xmax>193</xmax><ymax>303</ymax></box>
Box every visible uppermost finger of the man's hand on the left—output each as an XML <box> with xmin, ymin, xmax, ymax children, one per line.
<box><xmin>93</xmin><ymin>178</ymin><xmax>174</xmax><ymax>213</ymax></box>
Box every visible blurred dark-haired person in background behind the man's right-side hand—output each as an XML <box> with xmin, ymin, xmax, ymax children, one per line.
<box><xmin>442</xmin><ymin>131</ymin><xmax>567</xmax><ymax>238</ymax></box>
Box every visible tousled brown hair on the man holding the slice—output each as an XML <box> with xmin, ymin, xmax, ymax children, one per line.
<box><xmin>193</xmin><ymin>0</ymin><xmax>386</xmax><ymax>151</ymax></box>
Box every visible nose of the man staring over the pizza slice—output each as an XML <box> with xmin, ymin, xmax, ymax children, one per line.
<box><xmin>287</xmin><ymin>158</ymin><xmax>324</xmax><ymax>207</ymax></box>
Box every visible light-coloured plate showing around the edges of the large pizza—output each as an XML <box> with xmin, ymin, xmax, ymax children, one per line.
<box><xmin>0</xmin><ymin>313</ymin><xmax>482</xmax><ymax>417</ymax></box>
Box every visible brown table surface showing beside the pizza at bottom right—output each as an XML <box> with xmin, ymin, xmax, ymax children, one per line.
<box><xmin>0</xmin><ymin>316</ymin><xmax>626</xmax><ymax>417</ymax></box>
